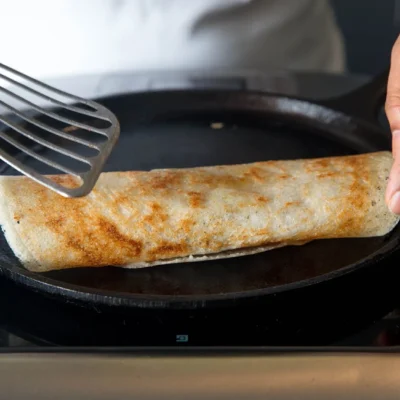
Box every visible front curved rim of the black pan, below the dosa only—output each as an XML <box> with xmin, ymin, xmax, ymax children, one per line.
<box><xmin>0</xmin><ymin>233</ymin><xmax>400</xmax><ymax>310</ymax></box>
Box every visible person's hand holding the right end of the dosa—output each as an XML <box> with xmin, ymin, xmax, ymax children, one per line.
<box><xmin>385</xmin><ymin>36</ymin><xmax>400</xmax><ymax>215</ymax></box>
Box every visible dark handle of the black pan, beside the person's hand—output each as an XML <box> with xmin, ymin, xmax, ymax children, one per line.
<box><xmin>319</xmin><ymin>68</ymin><xmax>389</xmax><ymax>124</ymax></box>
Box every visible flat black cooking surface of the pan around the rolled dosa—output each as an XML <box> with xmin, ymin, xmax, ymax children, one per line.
<box><xmin>0</xmin><ymin>90</ymin><xmax>396</xmax><ymax>295</ymax></box>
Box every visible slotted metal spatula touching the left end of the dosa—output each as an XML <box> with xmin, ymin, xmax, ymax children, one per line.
<box><xmin>0</xmin><ymin>64</ymin><xmax>120</xmax><ymax>197</ymax></box>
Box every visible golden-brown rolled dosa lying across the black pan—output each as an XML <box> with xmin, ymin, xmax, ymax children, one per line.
<box><xmin>0</xmin><ymin>152</ymin><xmax>399</xmax><ymax>272</ymax></box>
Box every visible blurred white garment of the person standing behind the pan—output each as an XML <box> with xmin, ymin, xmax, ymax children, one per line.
<box><xmin>0</xmin><ymin>0</ymin><xmax>345</xmax><ymax>99</ymax></box>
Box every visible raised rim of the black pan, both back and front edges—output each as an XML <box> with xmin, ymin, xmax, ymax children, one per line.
<box><xmin>0</xmin><ymin>89</ymin><xmax>400</xmax><ymax>310</ymax></box>
